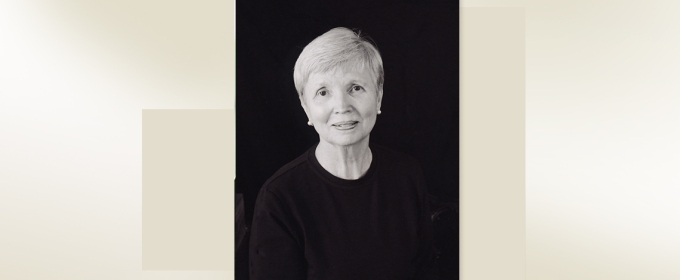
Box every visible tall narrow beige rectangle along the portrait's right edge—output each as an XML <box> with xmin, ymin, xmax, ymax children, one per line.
<box><xmin>460</xmin><ymin>8</ymin><xmax>526</xmax><ymax>280</ymax></box>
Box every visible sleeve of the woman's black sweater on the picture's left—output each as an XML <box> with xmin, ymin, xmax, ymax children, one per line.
<box><xmin>250</xmin><ymin>187</ymin><xmax>307</xmax><ymax>280</ymax></box>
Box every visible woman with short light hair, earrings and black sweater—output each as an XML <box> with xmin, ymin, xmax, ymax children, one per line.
<box><xmin>250</xmin><ymin>28</ymin><xmax>431</xmax><ymax>280</ymax></box>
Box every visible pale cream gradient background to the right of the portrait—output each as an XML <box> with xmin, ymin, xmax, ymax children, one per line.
<box><xmin>461</xmin><ymin>0</ymin><xmax>680</xmax><ymax>280</ymax></box>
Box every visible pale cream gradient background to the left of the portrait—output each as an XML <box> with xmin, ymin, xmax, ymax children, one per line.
<box><xmin>0</xmin><ymin>0</ymin><xmax>235</xmax><ymax>280</ymax></box>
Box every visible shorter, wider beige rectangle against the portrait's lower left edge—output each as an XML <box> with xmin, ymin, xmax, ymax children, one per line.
<box><xmin>142</xmin><ymin>110</ymin><xmax>235</xmax><ymax>270</ymax></box>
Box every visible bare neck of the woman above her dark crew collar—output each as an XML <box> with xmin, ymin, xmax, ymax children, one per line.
<box><xmin>315</xmin><ymin>137</ymin><xmax>373</xmax><ymax>180</ymax></box>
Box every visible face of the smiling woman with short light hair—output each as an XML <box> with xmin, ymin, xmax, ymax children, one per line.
<box><xmin>300</xmin><ymin>69</ymin><xmax>382</xmax><ymax>149</ymax></box>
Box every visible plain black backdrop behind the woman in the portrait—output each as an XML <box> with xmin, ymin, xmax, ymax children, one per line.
<box><xmin>235</xmin><ymin>0</ymin><xmax>458</xmax><ymax>275</ymax></box>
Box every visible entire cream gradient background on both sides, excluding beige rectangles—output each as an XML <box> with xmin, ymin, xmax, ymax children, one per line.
<box><xmin>0</xmin><ymin>0</ymin><xmax>680</xmax><ymax>280</ymax></box>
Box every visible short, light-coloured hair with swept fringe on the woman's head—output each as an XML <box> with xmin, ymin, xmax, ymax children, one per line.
<box><xmin>293</xmin><ymin>27</ymin><xmax>385</xmax><ymax>95</ymax></box>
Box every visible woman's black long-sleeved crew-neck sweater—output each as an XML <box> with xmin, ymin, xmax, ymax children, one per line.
<box><xmin>250</xmin><ymin>145</ymin><xmax>432</xmax><ymax>280</ymax></box>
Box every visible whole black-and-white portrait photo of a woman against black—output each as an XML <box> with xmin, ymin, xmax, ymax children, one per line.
<box><xmin>236</xmin><ymin>1</ymin><xmax>458</xmax><ymax>279</ymax></box>
